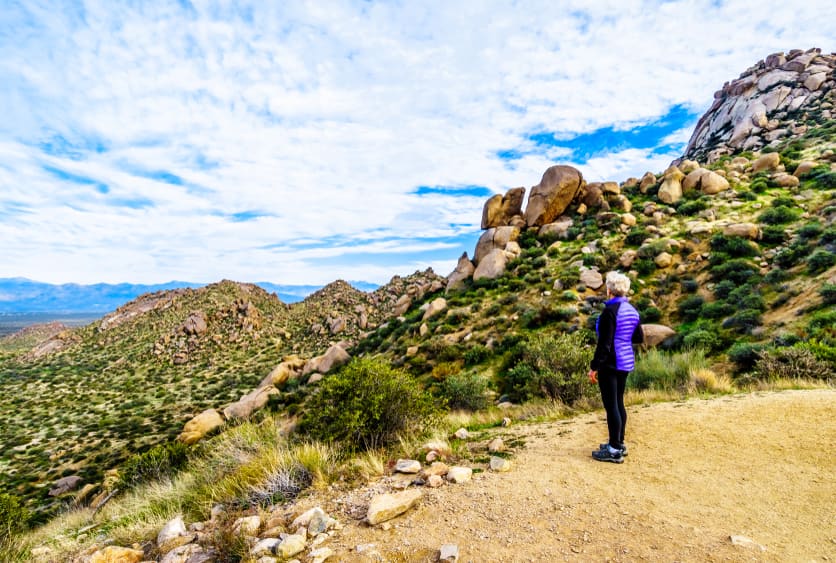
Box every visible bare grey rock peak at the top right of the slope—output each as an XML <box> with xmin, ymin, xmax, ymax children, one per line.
<box><xmin>685</xmin><ymin>49</ymin><xmax>836</xmax><ymax>163</ymax></box>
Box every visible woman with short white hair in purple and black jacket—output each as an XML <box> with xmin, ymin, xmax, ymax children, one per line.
<box><xmin>589</xmin><ymin>272</ymin><xmax>642</xmax><ymax>463</ymax></box>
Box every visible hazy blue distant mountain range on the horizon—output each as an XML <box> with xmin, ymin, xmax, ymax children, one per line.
<box><xmin>0</xmin><ymin>278</ymin><xmax>378</xmax><ymax>314</ymax></box>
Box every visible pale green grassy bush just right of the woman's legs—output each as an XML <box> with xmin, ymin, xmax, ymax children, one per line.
<box><xmin>627</xmin><ymin>349</ymin><xmax>708</xmax><ymax>390</ymax></box>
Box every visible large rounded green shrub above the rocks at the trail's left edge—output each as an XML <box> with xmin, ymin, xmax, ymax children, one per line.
<box><xmin>299</xmin><ymin>358</ymin><xmax>439</xmax><ymax>451</ymax></box>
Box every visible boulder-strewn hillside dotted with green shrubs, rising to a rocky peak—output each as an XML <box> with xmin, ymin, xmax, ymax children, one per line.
<box><xmin>0</xmin><ymin>50</ymin><xmax>836</xmax><ymax>524</ymax></box>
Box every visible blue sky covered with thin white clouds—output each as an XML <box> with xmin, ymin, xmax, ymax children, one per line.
<box><xmin>0</xmin><ymin>0</ymin><xmax>836</xmax><ymax>284</ymax></box>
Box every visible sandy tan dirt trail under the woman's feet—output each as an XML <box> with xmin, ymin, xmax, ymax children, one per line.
<box><xmin>316</xmin><ymin>389</ymin><xmax>836</xmax><ymax>562</ymax></box>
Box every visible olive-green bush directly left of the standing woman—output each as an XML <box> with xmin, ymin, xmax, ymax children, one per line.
<box><xmin>498</xmin><ymin>333</ymin><xmax>592</xmax><ymax>405</ymax></box>
